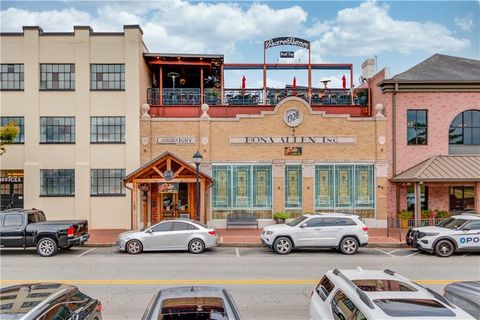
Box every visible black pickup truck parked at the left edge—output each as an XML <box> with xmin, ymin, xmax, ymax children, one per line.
<box><xmin>0</xmin><ymin>209</ymin><xmax>89</xmax><ymax>257</ymax></box>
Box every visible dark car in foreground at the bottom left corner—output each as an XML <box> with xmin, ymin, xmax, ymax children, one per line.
<box><xmin>0</xmin><ymin>283</ymin><xmax>102</xmax><ymax>320</ymax></box>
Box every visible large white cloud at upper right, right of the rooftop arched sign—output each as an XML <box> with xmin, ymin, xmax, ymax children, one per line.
<box><xmin>309</xmin><ymin>1</ymin><xmax>470</xmax><ymax>56</ymax></box>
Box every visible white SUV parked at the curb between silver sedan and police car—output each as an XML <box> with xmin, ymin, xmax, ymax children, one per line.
<box><xmin>260</xmin><ymin>213</ymin><xmax>368</xmax><ymax>254</ymax></box>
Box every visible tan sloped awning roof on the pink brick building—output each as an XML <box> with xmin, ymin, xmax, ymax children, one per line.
<box><xmin>391</xmin><ymin>155</ymin><xmax>480</xmax><ymax>182</ymax></box>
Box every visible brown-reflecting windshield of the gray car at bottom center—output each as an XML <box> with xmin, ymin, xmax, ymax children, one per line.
<box><xmin>158</xmin><ymin>297</ymin><xmax>228</xmax><ymax>320</ymax></box>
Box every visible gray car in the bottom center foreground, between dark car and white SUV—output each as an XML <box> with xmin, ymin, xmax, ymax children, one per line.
<box><xmin>142</xmin><ymin>286</ymin><xmax>240</xmax><ymax>320</ymax></box>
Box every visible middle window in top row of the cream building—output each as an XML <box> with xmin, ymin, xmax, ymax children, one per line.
<box><xmin>40</xmin><ymin>63</ymin><xmax>75</xmax><ymax>90</ymax></box>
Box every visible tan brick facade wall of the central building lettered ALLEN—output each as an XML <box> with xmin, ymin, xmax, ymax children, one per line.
<box><xmin>141</xmin><ymin>98</ymin><xmax>387</xmax><ymax>225</ymax></box>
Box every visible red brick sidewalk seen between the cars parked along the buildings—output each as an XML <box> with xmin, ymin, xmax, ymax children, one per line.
<box><xmin>86</xmin><ymin>228</ymin><xmax>405</xmax><ymax>247</ymax></box>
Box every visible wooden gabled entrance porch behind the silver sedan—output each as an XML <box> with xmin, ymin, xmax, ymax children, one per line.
<box><xmin>123</xmin><ymin>152</ymin><xmax>213</xmax><ymax>229</ymax></box>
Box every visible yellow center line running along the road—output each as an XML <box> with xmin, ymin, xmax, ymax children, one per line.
<box><xmin>0</xmin><ymin>279</ymin><xmax>465</xmax><ymax>285</ymax></box>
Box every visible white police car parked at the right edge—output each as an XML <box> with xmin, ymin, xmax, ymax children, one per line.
<box><xmin>406</xmin><ymin>213</ymin><xmax>480</xmax><ymax>257</ymax></box>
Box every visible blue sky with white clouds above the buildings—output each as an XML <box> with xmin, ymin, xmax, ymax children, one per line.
<box><xmin>0</xmin><ymin>0</ymin><xmax>480</xmax><ymax>88</ymax></box>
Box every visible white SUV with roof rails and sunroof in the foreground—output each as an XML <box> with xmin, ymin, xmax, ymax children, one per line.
<box><xmin>310</xmin><ymin>268</ymin><xmax>473</xmax><ymax>320</ymax></box>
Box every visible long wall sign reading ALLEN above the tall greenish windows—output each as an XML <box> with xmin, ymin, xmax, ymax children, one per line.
<box><xmin>230</xmin><ymin>136</ymin><xmax>357</xmax><ymax>145</ymax></box>
